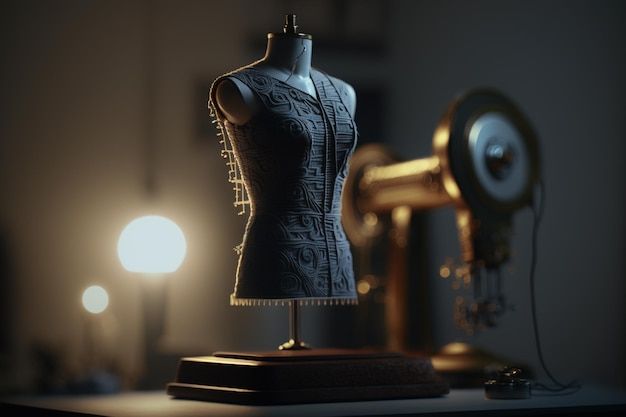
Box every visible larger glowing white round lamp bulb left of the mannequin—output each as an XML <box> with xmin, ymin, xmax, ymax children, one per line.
<box><xmin>117</xmin><ymin>216</ymin><xmax>187</xmax><ymax>274</ymax></box>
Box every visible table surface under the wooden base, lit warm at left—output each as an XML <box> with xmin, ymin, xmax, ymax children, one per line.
<box><xmin>4</xmin><ymin>385</ymin><xmax>626</xmax><ymax>417</ymax></box>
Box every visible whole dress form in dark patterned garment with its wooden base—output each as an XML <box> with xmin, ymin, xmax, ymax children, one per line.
<box><xmin>167</xmin><ymin>15</ymin><xmax>447</xmax><ymax>404</ymax></box>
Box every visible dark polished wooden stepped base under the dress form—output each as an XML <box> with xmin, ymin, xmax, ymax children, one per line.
<box><xmin>167</xmin><ymin>349</ymin><xmax>449</xmax><ymax>405</ymax></box>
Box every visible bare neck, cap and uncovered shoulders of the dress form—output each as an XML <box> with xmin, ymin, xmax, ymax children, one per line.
<box><xmin>216</xmin><ymin>14</ymin><xmax>356</xmax><ymax>125</ymax></box>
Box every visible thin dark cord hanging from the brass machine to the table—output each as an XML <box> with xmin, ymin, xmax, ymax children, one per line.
<box><xmin>530</xmin><ymin>180</ymin><xmax>582</xmax><ymax>396</ymax></box>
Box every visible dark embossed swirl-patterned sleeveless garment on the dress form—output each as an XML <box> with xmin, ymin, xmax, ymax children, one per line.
<box><xmin>210</xmin><ymin>67</ymin><xmax>357</xmax><ymax>305</ymax></box>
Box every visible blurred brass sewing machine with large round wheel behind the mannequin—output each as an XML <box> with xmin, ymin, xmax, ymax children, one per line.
<box><xmin>342</xmin><ymin>89</ymin><xmax>539</xmax><ymax>384</ymax></box>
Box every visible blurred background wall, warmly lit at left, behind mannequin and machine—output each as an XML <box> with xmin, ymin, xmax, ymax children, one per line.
<box><xmin>0</xmin><ymin>0</ymin><xmax>626</xmax><ymax>388</ymax></box>
